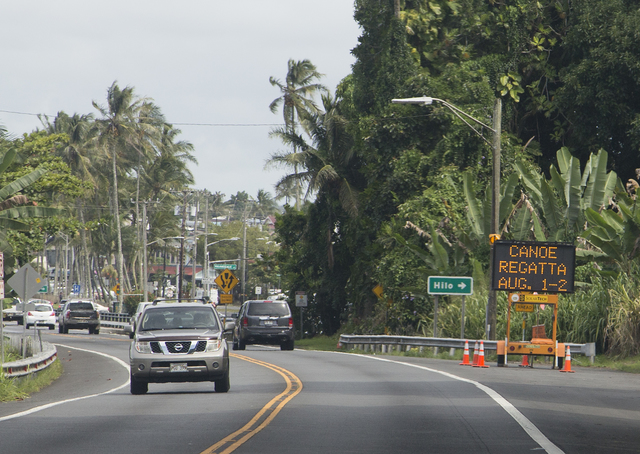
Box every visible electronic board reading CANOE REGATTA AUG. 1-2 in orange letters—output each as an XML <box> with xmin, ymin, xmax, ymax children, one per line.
<box><xmin>491</xmin><ymin>241</ymin><xmax>576</xmax><ymax>293</ymax></box>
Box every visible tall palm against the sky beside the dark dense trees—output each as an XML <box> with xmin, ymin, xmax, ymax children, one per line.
<box><xmin>267</xmin><ymin>59</ymin><xmax>327</xmax><ymax>210</ymax></box>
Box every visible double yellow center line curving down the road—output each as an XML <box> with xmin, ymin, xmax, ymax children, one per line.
<box><xmin>201</xmin><ymin>353</ymin><xmax>302</xmax><ymax>454</ymax></box>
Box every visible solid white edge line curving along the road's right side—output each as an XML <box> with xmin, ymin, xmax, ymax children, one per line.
<box><xmin>348</xmin><ymin>353</ymin><xmax>564</xmax><ymax>454</ymax></box>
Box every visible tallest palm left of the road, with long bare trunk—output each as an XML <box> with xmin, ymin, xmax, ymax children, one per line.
<box><xmin>92</xmin><ymin>82</ymin><xmax>154</xmax><ymax>309</ymax></box>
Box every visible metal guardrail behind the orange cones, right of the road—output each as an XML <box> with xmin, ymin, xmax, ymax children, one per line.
<box><xmin>340</xmin><ymin>334</ymin><xmax>596</xmax><ymax>362</ymax></box>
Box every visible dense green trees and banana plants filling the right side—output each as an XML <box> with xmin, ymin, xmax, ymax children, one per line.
<box><xmin>277</xmin><ymin>0</ymin><xmax>640</xmax><ymax>354</ymax></box>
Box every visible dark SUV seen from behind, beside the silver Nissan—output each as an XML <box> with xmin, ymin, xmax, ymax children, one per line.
<box><xmin>233</xmin><ymin>301</ymin><xmax>293</xmax><ymax>350</ymax></box>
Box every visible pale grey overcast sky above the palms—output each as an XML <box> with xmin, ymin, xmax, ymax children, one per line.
<box><xmin>0</xmin><ymin>0</ymin><xmax>360</xmax><ymax>202</ymax></box>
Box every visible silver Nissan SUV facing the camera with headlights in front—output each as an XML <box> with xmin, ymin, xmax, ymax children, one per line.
<box><xmin>129</xmin><ymin>302</ymin><xmax>230</xmax><ymax>394</ymax></box>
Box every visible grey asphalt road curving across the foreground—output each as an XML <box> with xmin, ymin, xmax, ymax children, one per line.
<box><xmin>0</xmin><ymin>331</ymin><xmax>640</xmax><ymax>454</ymax></box>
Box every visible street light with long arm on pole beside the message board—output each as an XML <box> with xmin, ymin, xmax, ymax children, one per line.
<box><xmin>391</xmin><ymin>96</ymin><xmax>502</xmax><ymax>340</ymax></box>
